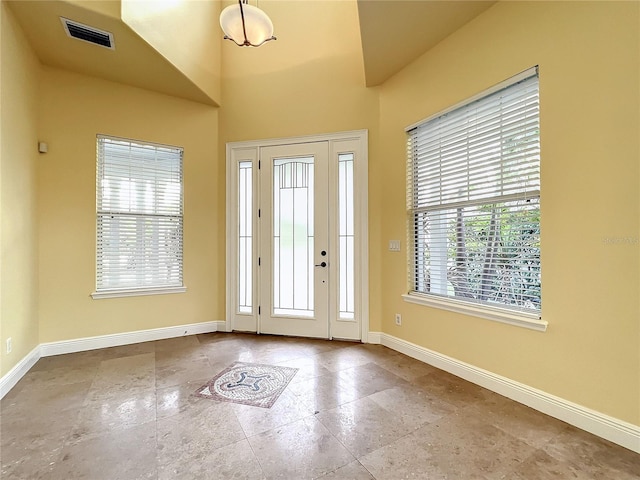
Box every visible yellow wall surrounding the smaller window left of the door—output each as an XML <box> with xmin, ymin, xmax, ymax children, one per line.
<box><xmin>38</xmin><ymin>68</ymin><xmax>225</xmax><ymax>343</ymax></box>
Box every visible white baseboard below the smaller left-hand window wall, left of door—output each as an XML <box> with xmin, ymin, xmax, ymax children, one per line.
<box><xmin>40</xmin><ymin>322</ymin><xmax>225</xmax><ymax>357</ymax></box>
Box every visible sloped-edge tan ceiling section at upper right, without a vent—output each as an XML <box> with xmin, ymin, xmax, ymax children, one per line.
<box><xmin>357</xmin><ymin>0</ymin><xmax>496</xmax><ymax>87</ymax></box>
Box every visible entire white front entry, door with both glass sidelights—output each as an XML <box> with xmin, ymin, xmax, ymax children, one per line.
<box><xmin>226</xmin><ymin>131</ymin><xmax>368</xmax><ymax>341</ymax></box>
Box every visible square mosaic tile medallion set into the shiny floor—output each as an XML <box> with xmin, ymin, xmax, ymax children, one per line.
<box><xmin>194</xmin><ymin>362</ymin><xmax>298</xmax><ymax>408</ymax></box>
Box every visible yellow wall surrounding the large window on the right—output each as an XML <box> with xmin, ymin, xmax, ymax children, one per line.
<box><xmin>378</xmin><ymin>2</ymin><xmax>640</xmax><ymax>425</ymax></box>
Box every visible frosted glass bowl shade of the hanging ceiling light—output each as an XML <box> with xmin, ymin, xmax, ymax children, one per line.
<box><xmin>220</xmin><ymin>0</ymin><xmax>275</xmax><ymax>47</ymax></box>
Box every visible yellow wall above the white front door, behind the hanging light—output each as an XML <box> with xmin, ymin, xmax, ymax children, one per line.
<box><xmin>220</xmin><ymin>0</ymin><xmax>381</xmax><ymax>331</ymax></box>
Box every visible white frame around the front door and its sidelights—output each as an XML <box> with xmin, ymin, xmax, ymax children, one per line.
<box><xmin>225</xmin><ymin>130</ymin><xmax>369</xmax><ymax>343</ymax></box>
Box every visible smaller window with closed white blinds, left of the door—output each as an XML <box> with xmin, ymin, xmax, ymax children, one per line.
<box><xmin>93</xmin><ymin>135</ymin><xmax>185</xmax><ymax>298</ymax></box>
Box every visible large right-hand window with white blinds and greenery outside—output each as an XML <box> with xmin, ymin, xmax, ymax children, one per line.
<box><xmin>407</xmin><ymin>68</ymin><xmax>541</xmax><ymax>319</ymax></box>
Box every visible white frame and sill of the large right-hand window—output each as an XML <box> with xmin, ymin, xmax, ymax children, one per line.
<box><xmin>402</xmin><ymin>66</ymin><xmax>548</xmax><ymax>331</ymax></box>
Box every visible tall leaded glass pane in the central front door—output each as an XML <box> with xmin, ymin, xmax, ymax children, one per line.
<box><xmin>272</xmin><ymin>157</ymin><xmax>314</xmax><ymax>317</ymax></box>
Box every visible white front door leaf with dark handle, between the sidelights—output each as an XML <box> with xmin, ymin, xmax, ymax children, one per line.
<box><xmin>259</xmin><ymin>142</ymin><xmax>331</xmax><ymax>338</ymax></box>
